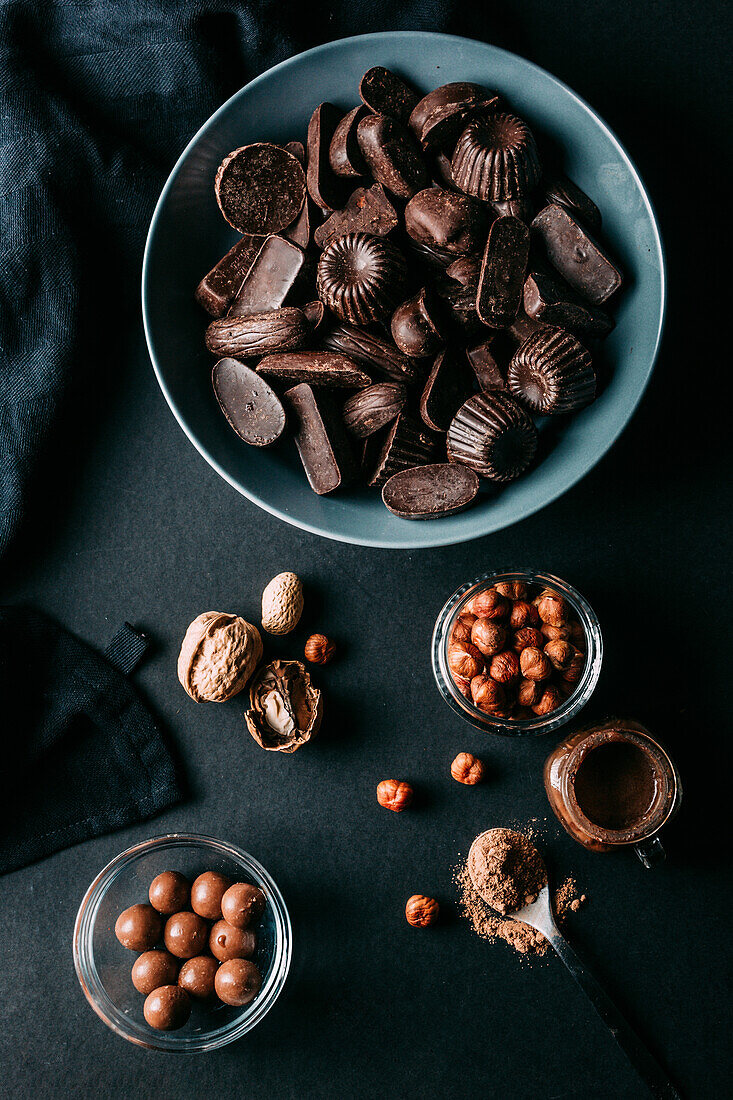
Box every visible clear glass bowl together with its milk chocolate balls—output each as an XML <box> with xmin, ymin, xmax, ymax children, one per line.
<box><xmin>74</xmin><ymin>834</ymin><xmax>292</xmax><ymax>1054</ymax></box>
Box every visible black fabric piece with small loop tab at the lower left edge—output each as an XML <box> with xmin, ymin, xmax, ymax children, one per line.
<box><xmin>0</xmin><ymin>607</ymin><xmax>180</xmax><ymax>875</ymax></box>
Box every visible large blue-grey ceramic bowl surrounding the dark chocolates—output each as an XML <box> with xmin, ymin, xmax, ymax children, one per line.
<box><xmin>142</xmin><ymin>31</ymin><xmax>665</xmax><ymax>549</ymax></box>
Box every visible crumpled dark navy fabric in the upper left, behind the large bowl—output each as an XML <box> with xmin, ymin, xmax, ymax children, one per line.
<box><xmin>0</xmin><ymin>0</ymin><xmax>449</xmax><ymax>556</ymax></box>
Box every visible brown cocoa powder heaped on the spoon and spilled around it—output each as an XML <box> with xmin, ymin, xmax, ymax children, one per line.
<box><xmin>455</xmin><ymin>829</ymin><xmax>586</xmax><ymax>956</ymax></box>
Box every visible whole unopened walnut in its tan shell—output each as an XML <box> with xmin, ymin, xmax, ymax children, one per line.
<box><xmin>178</xmin><ymin>612</ymin><xmax>262</xmax><ymax>703</ymax></box>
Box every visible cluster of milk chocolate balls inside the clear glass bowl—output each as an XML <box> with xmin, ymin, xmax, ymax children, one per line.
<box><xmin>114</xmin><ymin>871</ymin><xmax>265</xmax><ymax>1031</ymax></box>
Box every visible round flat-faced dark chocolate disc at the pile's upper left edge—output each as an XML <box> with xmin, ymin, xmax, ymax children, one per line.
<box><xmin>214</xmin><ymin>142</ymin><xmax>306</xmax><ymax>234</ymax></box>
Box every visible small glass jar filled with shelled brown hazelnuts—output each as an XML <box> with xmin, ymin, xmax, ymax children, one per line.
<box><xmin>433</xmin><ymin>570</ymin><xmax>603</xmax><ymax>737</ymax></box>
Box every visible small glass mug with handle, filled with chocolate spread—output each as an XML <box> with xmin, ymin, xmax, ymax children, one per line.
<box><xmin>545</xmin><ymin>718</ymin><xmax>682</xmax><ymax>867</ymax></box>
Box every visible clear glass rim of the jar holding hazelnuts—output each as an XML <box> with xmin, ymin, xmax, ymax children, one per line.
<box><xmin>430</xmin><ymin>569</ymin><xmax>603</xmax><ymax>737</ymax></box>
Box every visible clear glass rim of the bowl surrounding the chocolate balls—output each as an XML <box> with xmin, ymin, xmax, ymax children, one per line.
<box><xmin>74</xmin><ymin>833</ymin><xmax>293</xmax><ymax>1054</ymax></box>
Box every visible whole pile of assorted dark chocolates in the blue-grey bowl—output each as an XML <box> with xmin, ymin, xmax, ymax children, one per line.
<box><xmin>196</xmin><ymin>66</ymin><xmax>621</xmax><ymax>519</ymax></box>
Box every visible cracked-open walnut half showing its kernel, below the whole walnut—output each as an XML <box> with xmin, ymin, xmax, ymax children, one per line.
<box><xmin>244</xmin><ymin>661</ymin><xmax>324</xmax><ymax>752</ymax></box>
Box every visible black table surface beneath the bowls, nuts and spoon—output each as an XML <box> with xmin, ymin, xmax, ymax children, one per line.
<box><xmin>0</xmin><ymin>0</ymin><xmax>732</xmax><ymax>1100</ymax></box>
